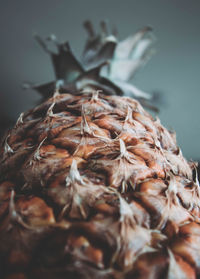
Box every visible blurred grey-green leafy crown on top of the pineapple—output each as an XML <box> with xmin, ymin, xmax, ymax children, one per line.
<box><xmin>24</xmin><ymin>21</ymin><xmax>157</xmax><ymax>111</ymax></box>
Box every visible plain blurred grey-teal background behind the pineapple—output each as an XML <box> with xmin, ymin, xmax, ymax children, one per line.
<box><xmin>0</xmin><ymin>0</ymin><xmax>200</xmax><ymax>161</ymax></box>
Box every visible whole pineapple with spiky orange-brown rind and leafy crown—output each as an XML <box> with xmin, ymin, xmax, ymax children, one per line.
<box><xmin>0</xmin><ymin>22</ymin><xmax>200</xmax><ymax>279</ymax></box>
